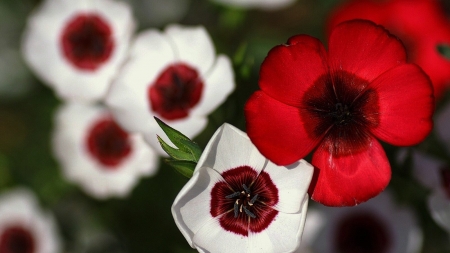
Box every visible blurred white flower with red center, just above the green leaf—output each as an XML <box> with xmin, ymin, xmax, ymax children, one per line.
<box><xmin>106</xmin><ymin>25</ymin><xmax>235</xmax><ymax>154</ymax></box>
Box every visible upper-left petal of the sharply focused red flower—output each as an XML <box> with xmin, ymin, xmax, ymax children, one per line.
<box><xmin>259</xmin><ymin>35</ymin><xmax>328</xmax><ymax>106</ymax></box>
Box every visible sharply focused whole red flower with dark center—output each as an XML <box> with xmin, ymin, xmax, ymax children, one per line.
<box><xmin>245</xmin><ymin>20</ymin><xmax>434</xmax><ymax>206</ymax></box>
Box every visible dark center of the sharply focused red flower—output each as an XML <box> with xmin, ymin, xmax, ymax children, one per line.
<box><xmin>301</xmin><ymin>71</ymin><xmax>379</xmax><ymax>156</ymax></box>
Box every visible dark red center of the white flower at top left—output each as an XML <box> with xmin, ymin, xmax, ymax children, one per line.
<box><xmin>61</xmin><ymin>14</ymin><xmax>114</xmax><ymax>71</ymax></box>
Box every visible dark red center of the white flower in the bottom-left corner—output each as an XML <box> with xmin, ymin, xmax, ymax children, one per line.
<box><xmin>0</xmin><ymin>226</ymin><xmax>36</xmax><ymax>253</ymax></box>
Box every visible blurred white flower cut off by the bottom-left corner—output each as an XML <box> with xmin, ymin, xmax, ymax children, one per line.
<box><xmin>0</xmin><ymin>188</ymin><xmax>61</xmax><ymax>253</ymax></box>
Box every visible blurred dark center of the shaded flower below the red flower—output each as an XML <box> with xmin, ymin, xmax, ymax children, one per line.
<box><xmin>333</xmin><ymin>212</ymin><xmax>392</xmax><ymax>253</ymax></box>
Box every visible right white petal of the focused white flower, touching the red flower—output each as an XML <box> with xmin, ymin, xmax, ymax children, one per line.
<box><xmin>264</xmin><ymin>160</ymin><xmax>314</xmax><ymax>213</ymax></box>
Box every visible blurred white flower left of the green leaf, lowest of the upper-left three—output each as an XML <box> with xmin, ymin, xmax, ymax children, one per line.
<box><xmin>53</xmin><ymin>103</ymin><xmax>158</xmax><ymax>198</ymax></box>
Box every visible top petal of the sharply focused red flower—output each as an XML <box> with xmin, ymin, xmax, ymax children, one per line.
<box><xmin>329</xmin><ymin>20</ymin><xmax>406</xmax><ymax>82</ymax></box>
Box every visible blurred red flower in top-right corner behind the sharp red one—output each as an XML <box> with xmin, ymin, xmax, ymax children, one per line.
<box><xmin>328</xmin><ymin>0</ymin><xmax>450</xmax><ymax>97</ymax></box>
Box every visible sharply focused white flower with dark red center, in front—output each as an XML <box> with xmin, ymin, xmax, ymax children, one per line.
<box><xmin>172</xmin><ymin>124</ymin><xmax>313</xmax><ymax>253</ymax></box>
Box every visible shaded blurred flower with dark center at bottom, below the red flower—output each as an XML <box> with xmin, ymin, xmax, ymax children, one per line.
<box><xmin>313</xmin><ymin>191</ymin><xmax>422</xmax><ymax>253</ymax></box>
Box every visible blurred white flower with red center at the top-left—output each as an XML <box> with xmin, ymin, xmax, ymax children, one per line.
<box><xmin>22</xmin><ymin>0</ymin><xmax>135</xmax><ymax>101</ymax></box>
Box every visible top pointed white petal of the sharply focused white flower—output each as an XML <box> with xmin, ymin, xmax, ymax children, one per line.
<box><xmin>195</xmin><ymin>123</ymin><xmax>267</xmax><ymax>173</ymax></box>
